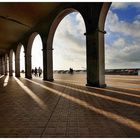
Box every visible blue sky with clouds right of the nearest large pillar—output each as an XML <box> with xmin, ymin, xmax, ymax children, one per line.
<box><xmin>105</xmin><ymin>2</ymin><xmax>140</xmax><ymax>69</ymax></box>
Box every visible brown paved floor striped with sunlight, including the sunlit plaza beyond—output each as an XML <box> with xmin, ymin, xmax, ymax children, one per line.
<box><xmin>0</xmin><ymin>76</ymin><xmax>140</xmax><ymax>138</ymax></box>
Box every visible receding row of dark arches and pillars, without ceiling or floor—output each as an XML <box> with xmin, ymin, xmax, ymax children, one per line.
<box><xmin>0</xmin><ymin>3</ymin><xmax>110</xmax><ymax>87</ymax></box>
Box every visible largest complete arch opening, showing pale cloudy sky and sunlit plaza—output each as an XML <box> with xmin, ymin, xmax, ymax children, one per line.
<box><xmin>53</xmin><ymin>11</ymin><xmax>86</xmax><ymax>84</ymax></box>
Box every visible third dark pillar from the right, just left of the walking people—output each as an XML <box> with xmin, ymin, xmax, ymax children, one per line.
<box><xmin>25</xmin><ymin>52</ymin><xmax>32</xmax><ymax>79</ymax></box>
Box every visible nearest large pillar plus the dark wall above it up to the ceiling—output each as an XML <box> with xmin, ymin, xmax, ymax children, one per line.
<box><xmin>81</xmin><ymin>3</ymin><xmax>106</xmax><ymax>87</ymax></box>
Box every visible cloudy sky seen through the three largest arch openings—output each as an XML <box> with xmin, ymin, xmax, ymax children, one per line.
<box><xmin>18</xmin><ymin>2</ymin><xmax>140</xmax><ymax>70</ymax></box>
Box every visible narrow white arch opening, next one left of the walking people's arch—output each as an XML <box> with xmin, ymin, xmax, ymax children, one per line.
<box><xmin>20</xmin><ymin>45</ymin><xmax>25</xmax><ymax>76</ymax></box>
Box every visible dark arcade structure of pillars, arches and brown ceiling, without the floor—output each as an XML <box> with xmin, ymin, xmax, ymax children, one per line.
<box><xmin>0</xmin><ymin>2</ymin><xmax>111</xmax><ymax>87</ymax></box>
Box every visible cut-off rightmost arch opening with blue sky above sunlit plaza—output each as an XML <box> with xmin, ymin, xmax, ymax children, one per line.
<box><xmin>105</xmin><ymin>2</ymin><xmax>140</xmax><ymax>88</ymax></box>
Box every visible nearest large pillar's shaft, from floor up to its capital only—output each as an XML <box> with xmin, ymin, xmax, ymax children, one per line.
<box><xmin>85</xmin><ymin>29</ymin><xmax>106</xmax><ymax>87</ymax></box>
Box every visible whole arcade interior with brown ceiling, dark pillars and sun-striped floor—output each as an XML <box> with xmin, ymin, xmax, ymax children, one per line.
<box><xmin>0</xmin><ymin>2</ymin><xmax>140</xmax><ymax>138</ymax></box>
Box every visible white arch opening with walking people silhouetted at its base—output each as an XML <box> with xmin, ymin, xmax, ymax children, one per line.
<box><xmin>31</xmin><ymin>35</ymin><xmax>43</xmax><ymax>78</ymax></box>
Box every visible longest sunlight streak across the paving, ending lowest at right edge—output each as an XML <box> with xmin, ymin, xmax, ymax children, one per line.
<box><xmin>25</xmin><ymin>79</ymin><xmax>140</xmax><ymax>131</ymax></box>
